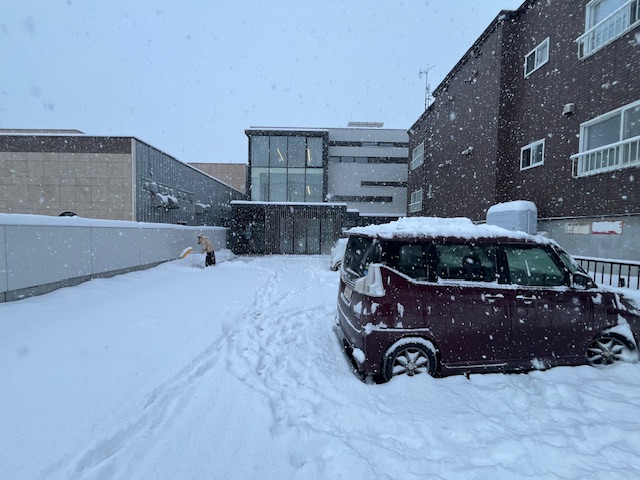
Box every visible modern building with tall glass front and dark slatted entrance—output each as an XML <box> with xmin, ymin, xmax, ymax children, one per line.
<box><xmin>233</xmin><ymin>123</ymin><xmax>408</xmax><ymax>254</ymax></box>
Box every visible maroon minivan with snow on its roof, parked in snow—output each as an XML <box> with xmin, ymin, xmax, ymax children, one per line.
<box><xmin>336</xmin><ymin>217</ymin><xmax>640</xmax><ymax>381</ymax></box>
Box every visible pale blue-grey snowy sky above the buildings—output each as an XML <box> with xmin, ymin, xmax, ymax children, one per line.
<box><xmin>0</xmin><ymin>0</ymin><xmax>522</xmax><ymax>163</ymax></box>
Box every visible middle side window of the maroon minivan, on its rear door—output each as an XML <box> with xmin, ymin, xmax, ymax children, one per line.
<box><xmin>436</xmin><ymin>243</ymin><xmax>496</xmax><ymax>282</ymax></box>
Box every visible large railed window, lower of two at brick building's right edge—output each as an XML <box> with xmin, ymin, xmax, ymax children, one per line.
<box><xmin>571</xmin><ymin>101</ymin><xmax>640</xmax><ymax>177</ymax></box>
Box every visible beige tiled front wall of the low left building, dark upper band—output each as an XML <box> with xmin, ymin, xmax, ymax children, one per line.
<box><xmin>0</xmin><ymin>135</ymin><xmax>135</xmax><ymax>220</ymax></box>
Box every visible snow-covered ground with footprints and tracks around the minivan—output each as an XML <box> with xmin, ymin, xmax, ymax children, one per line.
<box><xmin>0</xmin><ymin>251</ymin><xmax>640</xmax><ymax>480</ymax></box>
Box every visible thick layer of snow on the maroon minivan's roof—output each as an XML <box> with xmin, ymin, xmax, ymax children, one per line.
<box><xmin>346</xmin><ymin>217</ymin><xmax>552</xmax><ymax>243</ymax></box>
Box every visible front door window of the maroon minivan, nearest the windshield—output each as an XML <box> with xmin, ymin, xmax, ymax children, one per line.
<box><xmin>504</xmin><ymin>245</ymin><xmax>568</xmax><ymax>287</ymax></box>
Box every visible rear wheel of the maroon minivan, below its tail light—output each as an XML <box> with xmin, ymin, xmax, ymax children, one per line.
<box><xmin>382</xmin><ymin>341</ymin><xmax>437</xmax><ymax>382</ymax></box>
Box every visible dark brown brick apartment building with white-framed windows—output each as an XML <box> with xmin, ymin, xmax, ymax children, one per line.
<box><xmin>408</xmin><ymin>0</ymin><xmax>640</xmax><ymax>260</ymax></box>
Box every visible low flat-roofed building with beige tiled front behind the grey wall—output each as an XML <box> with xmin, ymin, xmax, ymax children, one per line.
<box><xmin>0</xmin><ymin>130</ymin><xmax>245</xmax><ymax>225</ymax></box>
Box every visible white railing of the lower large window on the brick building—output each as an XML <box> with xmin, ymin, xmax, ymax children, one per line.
<box><xmin>571</xmin><ymin>135</ymin><xmax>640</xmax><ymax>178</ymax></box>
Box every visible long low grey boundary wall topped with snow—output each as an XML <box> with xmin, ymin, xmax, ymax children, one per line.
<box><xmin>0</xmin><ymin>214</ymin><xmax>227</xmax><ymax>302</ymax></box>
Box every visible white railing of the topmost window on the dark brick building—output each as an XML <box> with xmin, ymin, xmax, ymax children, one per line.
<box><xmin>576</xmin><ymin>0</ymin><xmax>640</xmax><ymax>59</ymax></box>
